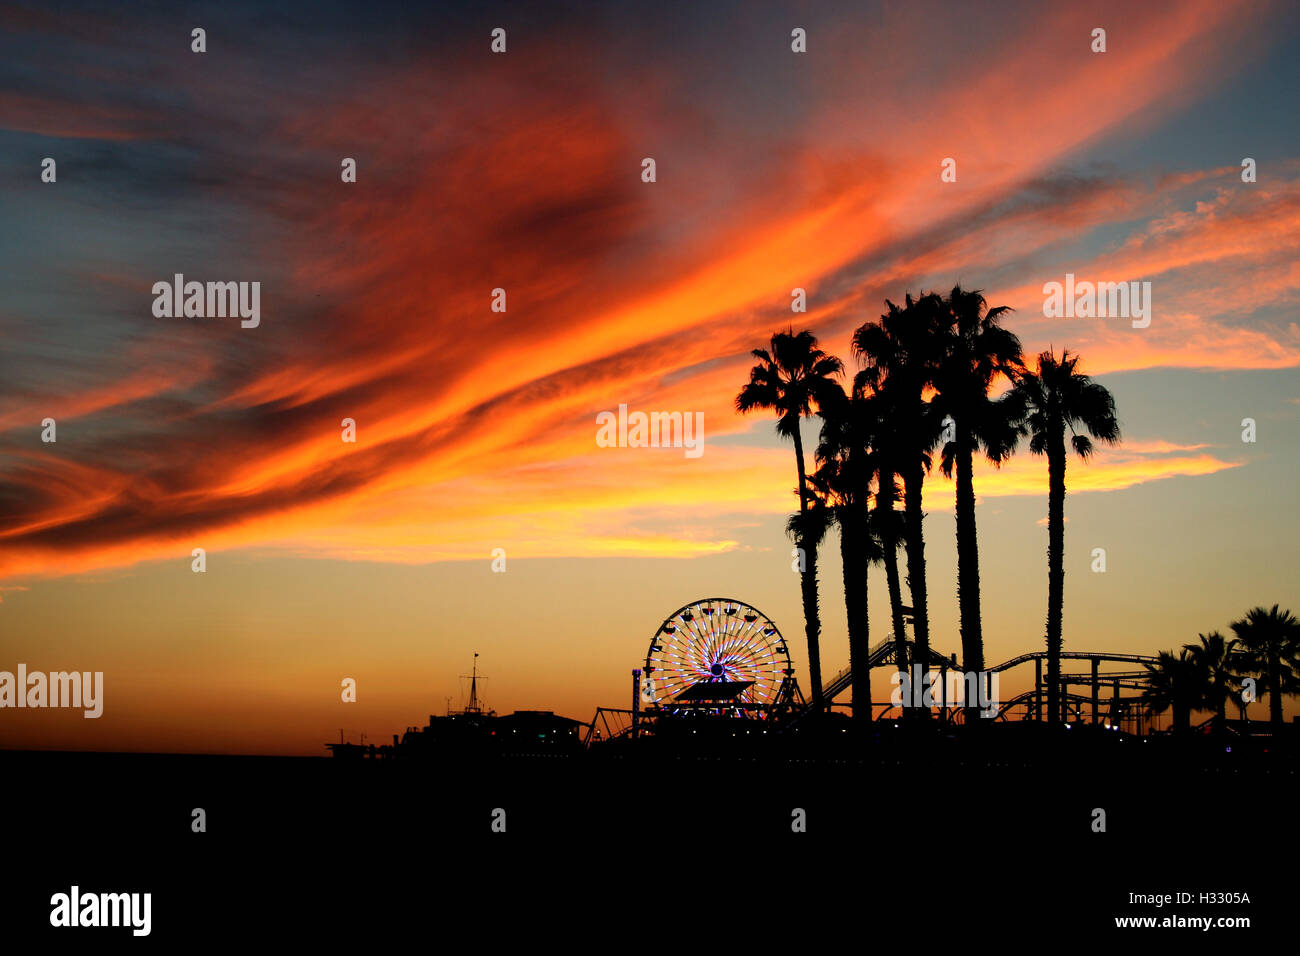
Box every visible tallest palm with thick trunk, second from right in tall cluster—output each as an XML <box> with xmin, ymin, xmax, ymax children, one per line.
<box><xmin>933</xmin><ymin>286</ymin><xmax>1024</xmax><ymax>724</ymax></box>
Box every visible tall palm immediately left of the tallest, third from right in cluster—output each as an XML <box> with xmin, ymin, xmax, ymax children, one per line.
<box><xmin>853</xmin><ymin>293</ymin><xmax>946</xmax><ymax>717</ymax></box>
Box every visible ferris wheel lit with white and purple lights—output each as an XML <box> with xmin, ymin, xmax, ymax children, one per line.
<box><xmin>642</xmin><ymin>597</ymin><xmax>794</xmax><ymax>715</ymax></box>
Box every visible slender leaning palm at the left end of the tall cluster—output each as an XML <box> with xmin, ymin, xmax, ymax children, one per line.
<box><xmin>736</xmin><ymin>329</ymin><xmax>844</xmax><ymax>710</ymax></box>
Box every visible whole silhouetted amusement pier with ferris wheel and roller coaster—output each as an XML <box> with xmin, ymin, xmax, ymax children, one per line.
<box><xmin>326</xmin><ymin>597</ymin><xmax>1185</xmax><ymax>757</ymax></box>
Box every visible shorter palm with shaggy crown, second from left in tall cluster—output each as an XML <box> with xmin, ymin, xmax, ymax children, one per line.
<box><xmin>809</xmin><ymin>388</ymin><xmax>880</xmax><ymax>732</ymax></box>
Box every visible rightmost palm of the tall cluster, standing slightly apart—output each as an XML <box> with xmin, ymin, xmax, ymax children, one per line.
<box><xmin>1017</xmin><ymin>350</ymin><xmax>1119</xmax><ymax>723</ymax></box>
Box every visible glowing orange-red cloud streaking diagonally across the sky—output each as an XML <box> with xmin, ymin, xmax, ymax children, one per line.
<box><xmin>0</xmin><ymin>3</ymin><xmax>1300</xmax><ymax>575</ymax></box>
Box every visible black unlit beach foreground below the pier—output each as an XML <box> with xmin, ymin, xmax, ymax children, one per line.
<box><xmin>0</xmin><ymin>728</ymin><xmax>1300</xmax><ymax>949</ymax></box>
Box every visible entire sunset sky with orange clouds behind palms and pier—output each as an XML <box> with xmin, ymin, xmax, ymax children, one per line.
<box><xmin>0</xmin><ymin>0</ymin><xmax>1300</xmax><ymax>754</ymax></box>
